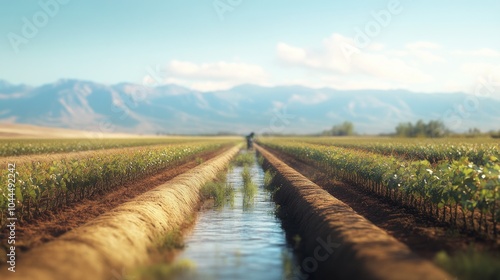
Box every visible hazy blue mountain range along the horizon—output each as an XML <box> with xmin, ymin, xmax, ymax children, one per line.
<box><xmin>0</xmin><ymin>79</ymin><xmax>500</xmax><ymax>134</ymax></box>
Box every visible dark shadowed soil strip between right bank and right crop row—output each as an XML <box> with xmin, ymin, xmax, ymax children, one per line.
<box><xmin>266</xmin><ymin>145</ymin><xmax>499</xmax><ymax>260</ymax></box>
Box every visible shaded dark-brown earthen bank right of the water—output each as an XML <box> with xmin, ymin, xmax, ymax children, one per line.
<box><xmin>257</xmin><ymin>147</ymin><xmax>452</xmax><ymax>280</ymax></box>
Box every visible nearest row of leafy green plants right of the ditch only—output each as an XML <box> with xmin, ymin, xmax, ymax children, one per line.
<box><xmin>260</xmin><ymin>139</ymin><xmax>500</xmax><ymax>238</ymax></box>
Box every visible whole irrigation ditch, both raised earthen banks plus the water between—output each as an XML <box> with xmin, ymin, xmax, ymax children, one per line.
<box><xmin>0</xmin><ymin>145</ymin><xmax>458</xmax><ymax>280</ymax></box>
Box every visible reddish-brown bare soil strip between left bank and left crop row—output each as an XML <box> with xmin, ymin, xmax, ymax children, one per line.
<box><xmin>0</xmin><ymin>148</ymin><xmax>227</xmax><ymax>252</ymax></box>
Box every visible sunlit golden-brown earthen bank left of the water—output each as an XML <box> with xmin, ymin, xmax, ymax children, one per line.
<box><xmin>0</xmin><ymin>144</ymin><xmax>239</xmax><ymax>280</ymax></box>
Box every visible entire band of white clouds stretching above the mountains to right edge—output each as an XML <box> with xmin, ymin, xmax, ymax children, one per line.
<box><xmin>143</xmin><ymin>37</ymin><xmax>500</xmax><ymax>94</ymax></box>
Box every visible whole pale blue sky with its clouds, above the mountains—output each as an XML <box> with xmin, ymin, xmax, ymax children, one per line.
<box><xmin>0</xmin><ymin>0</ymin><xmax>500</xmax><ymax>92</ymax></box>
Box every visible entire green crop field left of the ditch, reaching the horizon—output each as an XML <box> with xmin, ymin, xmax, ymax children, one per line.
<box><xmin>0</xmin><ymin>137</ymin><xmax>235</xmax><ymax>228</ymax></box>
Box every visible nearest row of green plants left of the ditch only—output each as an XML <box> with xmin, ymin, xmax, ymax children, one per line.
<box><xmin>0</xmin><ymin>141</ymin><xmax>232</xmax><ymax>226</ymax></box>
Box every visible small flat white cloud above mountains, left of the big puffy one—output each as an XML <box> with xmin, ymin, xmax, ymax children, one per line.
<box><xmin>164</xmin><ymin>60</ymin><xmax>268</xmax><ymax>91</ymax></box>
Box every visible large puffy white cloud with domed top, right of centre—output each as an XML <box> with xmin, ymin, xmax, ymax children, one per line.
<box><xmin>276</xmin><ymin>34</ymin><xmax>432</xmax><ymax>84</ymax></box>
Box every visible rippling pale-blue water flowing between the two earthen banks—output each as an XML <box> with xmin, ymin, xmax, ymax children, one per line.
<box><xmin>172</xmin><ymin>151</ymin><xmax>297</xmax><ymax>280</ymax></box>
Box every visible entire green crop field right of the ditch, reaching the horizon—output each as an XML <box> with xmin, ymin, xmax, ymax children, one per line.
<box><xmin>259</xmin><ymin>137</ymin><xmax>500</xmax><ymax>239</ymax></box>
